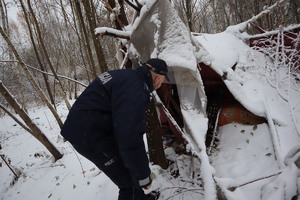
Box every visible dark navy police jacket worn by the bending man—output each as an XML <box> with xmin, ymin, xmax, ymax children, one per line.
<box><xmin>61</xmin><ymin>66</ymin><xmax>153</xmax><ymax>186</ymax></box>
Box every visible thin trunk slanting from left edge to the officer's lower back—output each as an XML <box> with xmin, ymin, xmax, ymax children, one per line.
<box><xmin>0</xmin><ymin>27</ymin><xmax>63</xmax><ymax>127</ymax></box>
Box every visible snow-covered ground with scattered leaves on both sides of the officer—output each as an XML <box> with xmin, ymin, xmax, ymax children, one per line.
<box><xmin>0</xmin><ymin>83</ymin><xmax>299</xmax><ymax>200</ymax></box>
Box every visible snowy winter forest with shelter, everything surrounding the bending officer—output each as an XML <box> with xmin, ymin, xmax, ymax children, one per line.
<box><xmin>0</xmin><ymin>0</ymin><xmax>300</xmax><ymax>200</ymax></box>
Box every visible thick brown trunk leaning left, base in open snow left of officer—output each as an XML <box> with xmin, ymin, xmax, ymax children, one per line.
<box><xmin>0</xmin><ymin>81</ymin><xmax>62</xmax><ymax>160</ymax></box>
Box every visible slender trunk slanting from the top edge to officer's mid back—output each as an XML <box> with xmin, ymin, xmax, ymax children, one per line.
<box><xmin>27</xmin><ymin>0</ymin><xmax>71</xmax><ymax>110</ymax></box>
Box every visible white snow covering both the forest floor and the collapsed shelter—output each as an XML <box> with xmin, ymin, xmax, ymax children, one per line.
<box><xmin>0</xmin><ymin>0</ymin><xmax>300</xmax><ymax>200</ymax></box>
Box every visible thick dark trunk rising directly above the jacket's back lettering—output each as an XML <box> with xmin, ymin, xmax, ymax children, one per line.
<box><xmin>82</xmin><ymin>0</ymin><xmax>108</xmax><ymax>73</ymax></box>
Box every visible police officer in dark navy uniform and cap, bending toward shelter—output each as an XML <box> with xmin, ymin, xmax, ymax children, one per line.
<box><xmin>61</xmin><ymin>58</ymin><xmax>168</xmax><ymax>200</ymax></box>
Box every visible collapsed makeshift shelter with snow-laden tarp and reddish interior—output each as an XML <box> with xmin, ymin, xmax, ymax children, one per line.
<box><xmin>96</xmin><ymin>0</ymin><xmax>300</xmax><ymax>200</ymax></box>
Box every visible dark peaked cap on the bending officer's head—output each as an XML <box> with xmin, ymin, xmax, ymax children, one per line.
<box><xmin>145</xmin><ymin>58</ymin><xmax>170</xmax><ymax>81</ymax></box>
